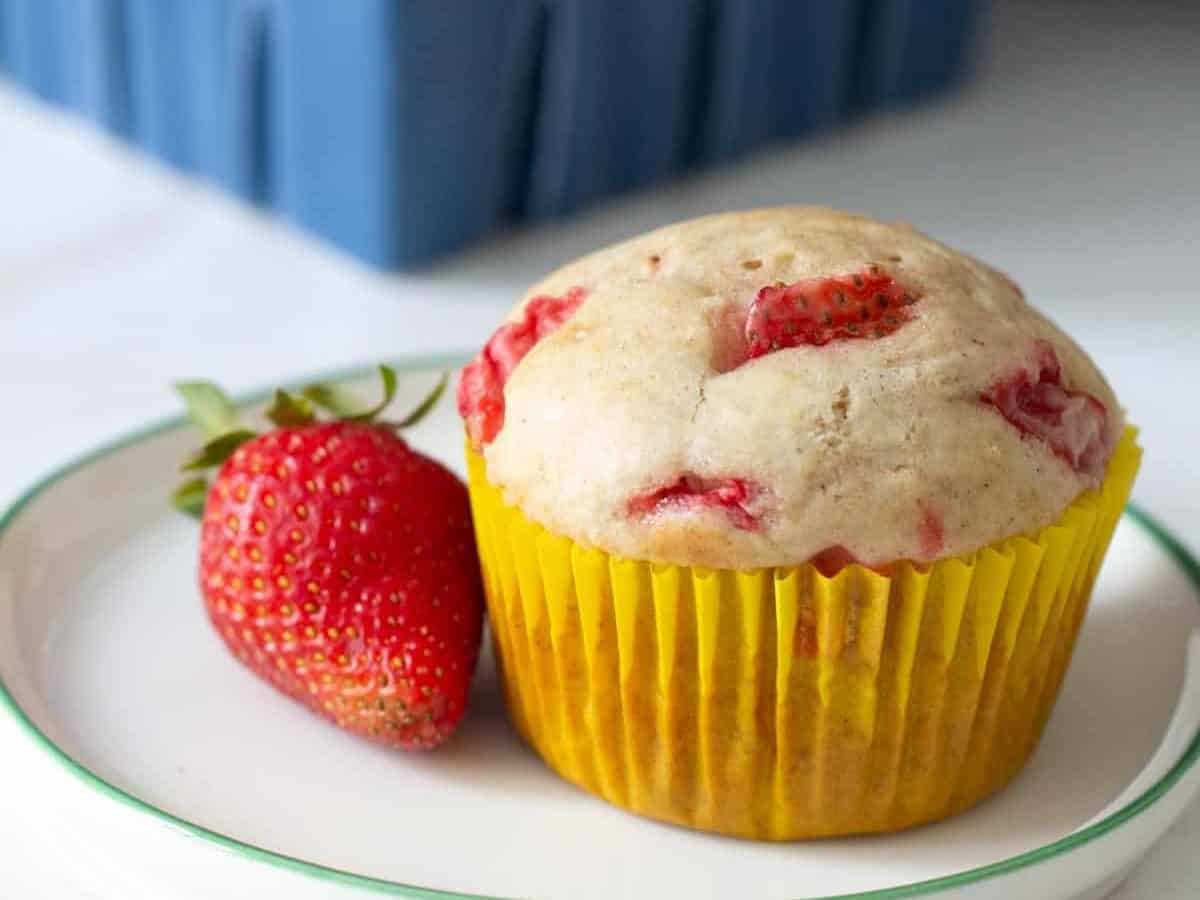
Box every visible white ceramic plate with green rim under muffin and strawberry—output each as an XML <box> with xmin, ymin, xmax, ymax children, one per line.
<box><xmin>0</xmin><ymin>360</ymin><xmax>1200</xmax><ymax>900</ymax></box>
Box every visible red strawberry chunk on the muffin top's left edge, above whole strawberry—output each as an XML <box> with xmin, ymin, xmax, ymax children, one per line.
<box><xmin>457</xmin><ymin>287</ymin><xmax>587</xmax><ymax>450</ymax></box>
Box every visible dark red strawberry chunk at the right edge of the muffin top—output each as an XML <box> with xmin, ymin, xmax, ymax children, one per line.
<box><xmin>982</xmin><ymin>341</ymin><xmax>1110</xmax><ymax>478</ymax></box>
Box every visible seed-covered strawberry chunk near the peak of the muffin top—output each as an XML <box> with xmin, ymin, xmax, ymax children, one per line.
<box><xmin>745</xmin><ymin>265</ymin><xmax>917</xmax><ymax>359</ymax></box>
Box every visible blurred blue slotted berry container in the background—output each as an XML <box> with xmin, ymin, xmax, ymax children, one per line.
<box><xmin>0</xmin><ymin>0</ymin><xmax>983</xmax><ymax>269</ymax></box>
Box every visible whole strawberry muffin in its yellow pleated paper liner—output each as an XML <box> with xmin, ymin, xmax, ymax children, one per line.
<box><xmin>458</xmin><ymin>208</ymin><xmax>1139</xmax><ymax>840</ymax></box>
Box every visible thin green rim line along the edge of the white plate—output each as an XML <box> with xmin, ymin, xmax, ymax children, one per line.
<box><xmin>0</xmin><ymin>353</ymin><xmax>1200</xmax><ymax>900</ymax></box>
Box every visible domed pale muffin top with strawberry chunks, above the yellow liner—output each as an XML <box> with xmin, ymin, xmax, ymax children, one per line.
<box><xmin>458</xmin><ymin>208</ymin><xmax>1123</xmax><ymax>569</ymax></box>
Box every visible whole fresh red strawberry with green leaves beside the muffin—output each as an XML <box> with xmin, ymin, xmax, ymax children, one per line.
<box><xmin>175</xmin><ymin>367</ymin><xmax>484</xmax><ymax>749</ymax></box>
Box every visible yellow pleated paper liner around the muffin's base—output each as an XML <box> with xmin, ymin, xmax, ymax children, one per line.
<box><xmin>468</xmin><ymin>428</ymin><xmax>1141</xmax><ymax>840</ymax></box>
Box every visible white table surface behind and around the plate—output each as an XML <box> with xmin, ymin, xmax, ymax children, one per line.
<box><xmin>0</xmin><ymin>0</ymin><xmax>1200</xmax><ymax>900</ymax></box>
